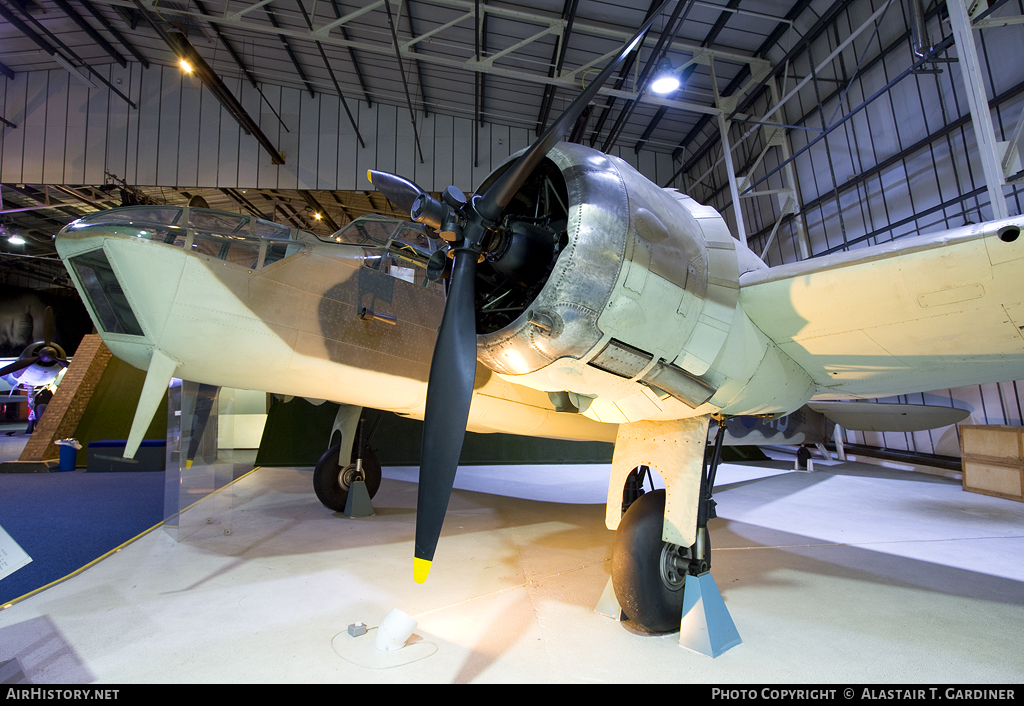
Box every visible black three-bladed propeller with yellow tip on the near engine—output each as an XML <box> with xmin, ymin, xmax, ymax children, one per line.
<box><xmin>368</xmin><ymin>12</ymin><xmax>664</xmax><ymax>583</ymax></box>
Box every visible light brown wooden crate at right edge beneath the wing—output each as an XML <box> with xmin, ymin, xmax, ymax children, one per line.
<box><xmin>961</xmin><ymin>425</ymin><xmax>1024</xmax><ymax>502</ymax></box>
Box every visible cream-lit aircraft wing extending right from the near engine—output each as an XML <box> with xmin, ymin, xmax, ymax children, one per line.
<box><xmin>740</xmin><ymin>218</ymin><xmax>1024</xmax><ymax>400</ymax></box>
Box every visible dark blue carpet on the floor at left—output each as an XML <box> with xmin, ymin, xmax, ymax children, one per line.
<box><xmin>0</xmin><ymin>471</ymin><xmax>164</xmax><ymax>604</ymax></box>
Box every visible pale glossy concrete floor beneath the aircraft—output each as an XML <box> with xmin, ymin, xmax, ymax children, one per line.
<box><xmin>0</xmin><ymin>450</ymin><xmax>1024</xmax><ymax>684</ymax></box>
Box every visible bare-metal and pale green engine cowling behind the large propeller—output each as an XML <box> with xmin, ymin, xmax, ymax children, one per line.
<box><xmin>468</xmin><ymin>142</ymin><xmax>809</xmax><ymax>423</ymax></box>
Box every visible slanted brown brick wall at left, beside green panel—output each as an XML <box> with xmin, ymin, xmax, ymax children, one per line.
<box><xmin>18</xmin><ymin>333</ymin><xmax>112</xmax><ymax>461</ymax></box>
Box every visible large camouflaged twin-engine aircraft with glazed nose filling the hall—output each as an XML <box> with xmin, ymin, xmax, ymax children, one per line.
<box><xmin>56</xmin><ymin>17</ymin><xmax>1024</xmax><ymax>631</ymax></box>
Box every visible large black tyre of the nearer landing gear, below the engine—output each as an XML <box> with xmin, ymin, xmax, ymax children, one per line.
<box><xmin>611</xmin><ymin>490</ymin><xmax>689</xmax><ymax>632</ymax></box>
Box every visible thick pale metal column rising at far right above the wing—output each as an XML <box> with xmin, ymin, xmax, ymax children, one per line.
<box><xmin>946</xmin><ymin>0</ymin><xmax>1010</xmax><ymax>220</ymax></box>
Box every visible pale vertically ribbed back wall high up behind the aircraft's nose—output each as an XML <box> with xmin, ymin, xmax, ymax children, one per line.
<box><xmin>0</xmin><ymin>64</ymin><xmax>679</xmax><ymax>192</ymax></box>
